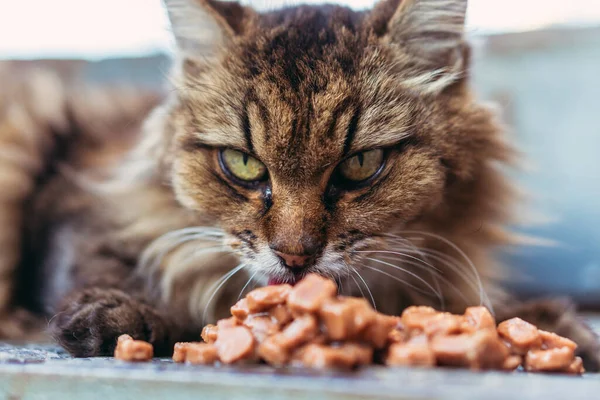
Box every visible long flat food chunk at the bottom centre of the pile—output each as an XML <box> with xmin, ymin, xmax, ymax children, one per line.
<box><xmin>293</xmin><ymin>343</ymin><xmax>373</xmax><ymax>369</ymax></box>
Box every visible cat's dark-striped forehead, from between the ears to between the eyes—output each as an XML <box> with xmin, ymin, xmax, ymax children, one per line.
<box><xmin>232</xmin><ymin>7</ymin><xmax>361</xmax><ymax>176</ymax></box>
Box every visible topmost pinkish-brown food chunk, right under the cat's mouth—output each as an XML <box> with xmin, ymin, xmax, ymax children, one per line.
<box><xmin>288</xmin><ymin>274</ymin><xmax>337</xmax><ymax>313</ymax></box>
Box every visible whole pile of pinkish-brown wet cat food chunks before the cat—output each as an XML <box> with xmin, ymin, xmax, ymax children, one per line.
<box><xmin>115</xmin><ymin>275</ymin><xmax>584</xmax><ymax>374</ymax></box>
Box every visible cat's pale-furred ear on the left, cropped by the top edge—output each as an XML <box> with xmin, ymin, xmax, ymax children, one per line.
<box><xmin>163</xmin><ymin>0</ymin><xmax>250</xmax><ymax>58</ymax></box>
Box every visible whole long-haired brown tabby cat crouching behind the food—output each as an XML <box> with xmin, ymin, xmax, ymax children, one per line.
<box><xmin>0</xmin><ymin>0</ymin><xmax>599</xmax><ymax>368</ymax></box>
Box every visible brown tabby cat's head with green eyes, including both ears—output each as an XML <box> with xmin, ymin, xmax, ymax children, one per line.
<box><xmin>162</xmin><ymin>0</ymin><xmax>504</xmax><ymax>282</ymax></box>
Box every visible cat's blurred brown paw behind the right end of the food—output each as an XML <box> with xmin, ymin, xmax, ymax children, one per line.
<box><xmin>499</xmin><ymin>298</ymin><xmax>600</xmax><ymax>372</ymax></box>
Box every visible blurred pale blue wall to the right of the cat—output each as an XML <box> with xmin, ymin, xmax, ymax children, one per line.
<box><xmin>474</xmin><ymin>28</ymin><xmax>600</xmax><ymax>304</ymax></box>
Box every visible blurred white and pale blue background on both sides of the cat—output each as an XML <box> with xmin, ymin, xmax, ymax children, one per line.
<box><xmin>0</xmin><ymin>0</ymin><xmax>600</xmax><ymax>307</ymax></box>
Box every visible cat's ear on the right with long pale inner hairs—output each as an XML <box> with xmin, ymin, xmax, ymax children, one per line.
<box><xmin>385</xmin><ymin>0</ymin><xmax>469</xmax><ymax>91</ymax></box>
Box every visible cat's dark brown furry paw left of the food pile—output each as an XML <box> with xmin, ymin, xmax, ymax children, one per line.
<box><xmin>50</xmin><ymin>288</ymin><xmax>166</xmax><ymax>357</ymax></box>
